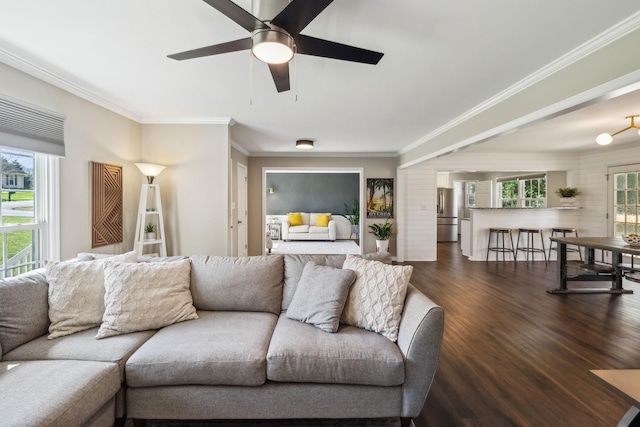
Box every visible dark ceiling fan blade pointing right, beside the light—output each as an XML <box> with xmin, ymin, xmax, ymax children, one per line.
<box><xmin>295</xmin><ymin>34</ymin><xmax>384</xmax><ymax>65</ymax></box>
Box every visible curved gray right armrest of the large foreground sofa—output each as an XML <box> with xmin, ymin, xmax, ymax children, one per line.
<box><xmin>398</xmin><ymin>285</ymin><xmax>444</xmax><ymax>418</ymax></box>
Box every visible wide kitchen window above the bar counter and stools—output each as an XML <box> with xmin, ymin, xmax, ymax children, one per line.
<box><xmin>498</xmin><ymin>175</ymin><xmax>547</xmax><ymax>208</ymax></box>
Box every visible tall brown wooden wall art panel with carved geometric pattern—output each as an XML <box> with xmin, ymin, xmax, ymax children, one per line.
<box><xmin>91</xmin><ymin>162</ymin><xmax>123</xmax><ymax>248</ymax></box>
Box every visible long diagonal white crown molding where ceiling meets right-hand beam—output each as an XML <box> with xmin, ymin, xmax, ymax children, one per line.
<box><xmin>398</xmin><ymin>12</ymin><xmax>640</xmax><ymax>155</ymax></box>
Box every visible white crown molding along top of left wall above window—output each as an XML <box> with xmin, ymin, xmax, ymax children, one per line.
<box><xmin>0</xmin><ymin>46</ymin><xmax>141</xmax><ymax>123</ymax></box>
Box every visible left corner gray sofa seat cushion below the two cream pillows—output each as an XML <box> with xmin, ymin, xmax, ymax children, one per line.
<box><xmin>3</xmin><ymin>327</ymin><xmax>155</xmax><ymax>382</ymax></box>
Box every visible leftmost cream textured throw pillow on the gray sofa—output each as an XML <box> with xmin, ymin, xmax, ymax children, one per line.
<box><xmin>45</xmin><ymin>251</ymin><xmax>138</xmax><ymax>339</ymax></box>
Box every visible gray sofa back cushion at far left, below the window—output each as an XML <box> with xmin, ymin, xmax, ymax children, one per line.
<box><xmin>0</xmin><ymin>269</ymin><xmax>49</xmax><ymax>359</ymax></box>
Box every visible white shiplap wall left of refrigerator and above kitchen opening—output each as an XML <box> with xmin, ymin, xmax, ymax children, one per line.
<box><xmin>402</xmin><ymin>150</ymin><xmax>580</xmax><ymax>261</ymax></box>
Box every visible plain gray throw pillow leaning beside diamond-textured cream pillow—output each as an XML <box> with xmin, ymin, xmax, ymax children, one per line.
<box><xmin>287</xmin><ymin>261</ymin><xmax>356</xmax><ymax>332</ymax></box>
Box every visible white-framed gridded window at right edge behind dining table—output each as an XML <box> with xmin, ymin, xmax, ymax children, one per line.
<box><xmin>613</xmin><ymin>171</ymin><xmax>640</xmax><ymax>237</ymax></box>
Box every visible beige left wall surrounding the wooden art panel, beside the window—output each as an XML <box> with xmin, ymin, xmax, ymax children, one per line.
<box><xmin>0</xmin><ymin>64</ymin><xmax>141</xmax><ymax>259</ymax></box>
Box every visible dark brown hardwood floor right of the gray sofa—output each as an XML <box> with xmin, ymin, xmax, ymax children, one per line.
<box><xmin>407</xmin><ymin>243</ymin><xmax>640</xmax><ymax>427</ymax></box>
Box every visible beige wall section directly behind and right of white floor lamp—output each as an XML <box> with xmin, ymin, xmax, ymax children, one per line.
<box><xmin>140</xmin><ymin>124</ymin><xmax>231</xmax><ymax>255</ymax></box>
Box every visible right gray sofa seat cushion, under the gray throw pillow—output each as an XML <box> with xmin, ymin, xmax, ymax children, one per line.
<box><xmin>267</xmin><ymin>313</ymin><xmax>404</xmax><ymax>386</ymax></box>
